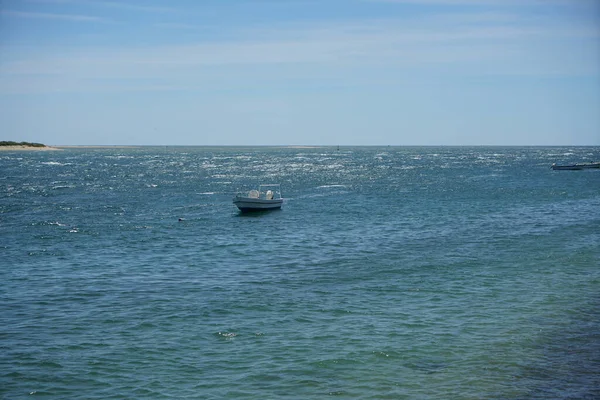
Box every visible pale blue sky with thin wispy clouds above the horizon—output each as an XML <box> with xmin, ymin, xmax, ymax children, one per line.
<box><xmin>0</xmin><ymin>0</ymin><xmax>600</xmax><ymax>146</ymax></box>
